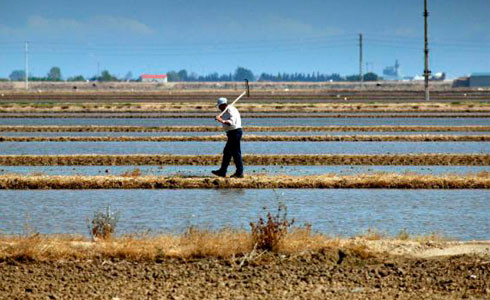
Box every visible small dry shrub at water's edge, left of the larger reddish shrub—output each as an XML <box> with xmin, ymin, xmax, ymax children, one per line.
<box><xmin>88</xmin><ymin>206</ymin><xmax>119</xmax><ymax>241</ymax></box>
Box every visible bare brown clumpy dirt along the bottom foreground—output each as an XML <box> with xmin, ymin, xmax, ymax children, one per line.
<box><xmin>0</xmin><ymin>239</ymin><xmax>490</xmax><ymax>299</ymax></box>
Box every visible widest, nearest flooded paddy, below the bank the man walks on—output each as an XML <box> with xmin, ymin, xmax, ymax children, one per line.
<box><xmin>0</xmin><ymin>189</ymin><xmax>490</xmax><ymax>240</ymax></box>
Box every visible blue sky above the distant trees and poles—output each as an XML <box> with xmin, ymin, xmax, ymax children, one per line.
<box><xmin>0</xmin><ymin>0</ymin><xmax>490</xmax><ymax>77</ymax></box>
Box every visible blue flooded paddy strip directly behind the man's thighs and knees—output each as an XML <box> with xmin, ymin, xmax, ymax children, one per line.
<box><xmin>0</xmin><ymin>142</ymin><xmax>490</xmax><ymax>155</ymax></box>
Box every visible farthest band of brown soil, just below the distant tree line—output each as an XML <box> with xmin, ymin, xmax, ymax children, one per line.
<box><xmin>0</xmin><ymin>82</ymin><xmax>490</xmax><ymax>103</ymax></box>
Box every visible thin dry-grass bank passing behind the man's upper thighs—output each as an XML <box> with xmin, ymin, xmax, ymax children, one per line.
<box><xmin>0</xmin><ymin>134</ymin><xmax>490</xmax><ymax>142</ymax></box>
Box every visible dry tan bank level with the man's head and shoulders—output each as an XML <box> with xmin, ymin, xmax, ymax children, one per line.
<box><xmin>0</xmin><ymin>101</ymin><xmax>490</xmax><ymax>114</ymax></box>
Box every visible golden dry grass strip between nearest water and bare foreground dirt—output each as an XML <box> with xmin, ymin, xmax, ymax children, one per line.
<box><xmin>0</xmin><ymin>227</ymin><xmax>470</xmax><ymax>262</ymax></box>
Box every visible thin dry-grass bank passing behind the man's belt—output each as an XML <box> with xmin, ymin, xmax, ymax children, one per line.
<box><xmin>0</xmin><ymin>125</ymin><xmax>490</xmax><ymax>132</ymax></box>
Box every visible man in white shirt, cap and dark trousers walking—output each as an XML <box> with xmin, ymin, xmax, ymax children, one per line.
<box><xmin>211</xmin><ymin>98</ymin><xmax>243</xmax><ymax>178</ymax></box>
